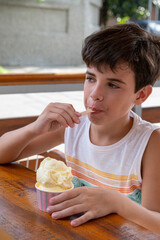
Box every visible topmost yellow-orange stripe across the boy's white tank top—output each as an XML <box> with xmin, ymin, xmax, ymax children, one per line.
<box><xmin>66</xmin><ymin>155</ymin><xmax>138</xmax><ymax>181</ymax></box>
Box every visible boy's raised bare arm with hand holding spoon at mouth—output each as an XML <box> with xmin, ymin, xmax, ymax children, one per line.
<box><xmin>0</xmin><ymin>103</ymin><xmax>79</xmax><ymax>163</ymax></box>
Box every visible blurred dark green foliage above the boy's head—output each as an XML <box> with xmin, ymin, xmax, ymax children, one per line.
<box><xmin>108</xmin><ymin>0</ymin><xmax>148</xmax><ymax>22</ymax></box>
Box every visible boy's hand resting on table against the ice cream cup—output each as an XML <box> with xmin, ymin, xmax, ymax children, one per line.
<box><xmin>47</xmin><ymin>187</ymin><xmax>120</xmax><ymax>227</ymax></box>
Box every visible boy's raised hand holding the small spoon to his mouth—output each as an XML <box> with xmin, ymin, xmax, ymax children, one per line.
<box><xmin>33</xmin><ymin>103</ymin><xmax>81</xmax><ymax>134</ymax></box>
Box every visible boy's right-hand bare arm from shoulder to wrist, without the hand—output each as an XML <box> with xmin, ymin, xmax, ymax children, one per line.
<box><xmin>116</xmin><ymin>130</ymin><xmax>160</xmax><ymax>234</ymax></box>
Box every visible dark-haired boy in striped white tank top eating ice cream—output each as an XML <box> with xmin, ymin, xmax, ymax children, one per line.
<box><xmin>0</xmin><ymin>24</ymin><xmax>160</xmax><ymax>234</ymax></box>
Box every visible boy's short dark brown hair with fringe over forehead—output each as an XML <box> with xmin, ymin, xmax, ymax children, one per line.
<box><xmin>82</xmin><ymin>23</ymin><xmax>160</xmax><ymax>92</ymax></box>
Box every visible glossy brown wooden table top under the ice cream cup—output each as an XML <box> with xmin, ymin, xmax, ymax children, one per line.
<box><xmin>0</xmin><ymin>163</ymin><xmax>160</xmax><ymax>240</ymax></box>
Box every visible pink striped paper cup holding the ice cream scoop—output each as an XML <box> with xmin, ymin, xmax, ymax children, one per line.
<box><xmin>35</xmin><ymin>184</ymin><xmax>74</xmax><ymax>212</ymax></box>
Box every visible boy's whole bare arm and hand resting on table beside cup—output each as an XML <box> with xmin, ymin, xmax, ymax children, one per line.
<box><xmin>48</xmin><ymin>131</ymin><xmax>160</xmax><ymax>234</ymax></box>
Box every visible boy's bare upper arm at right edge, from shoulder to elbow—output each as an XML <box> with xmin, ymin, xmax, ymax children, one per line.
<box><xmin>141</xmin><ymin>130</ymin><xmax>160</xmax><ymax>213</ymax></box>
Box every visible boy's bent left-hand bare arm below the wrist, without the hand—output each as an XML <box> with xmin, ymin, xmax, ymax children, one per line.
<box><xmin>0</xmin><ymin>125</ymin><xmax>64</xmax><ymax>163</ymax></box>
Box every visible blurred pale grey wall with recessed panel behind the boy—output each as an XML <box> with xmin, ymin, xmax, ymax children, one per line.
<box><xmin>0</xmin><ymin>0</ymin><xmax>101</xmax><ymax>67</ymax></box>
